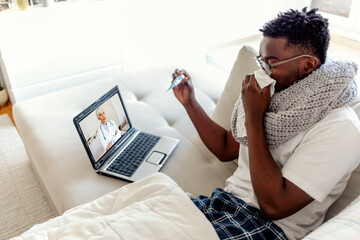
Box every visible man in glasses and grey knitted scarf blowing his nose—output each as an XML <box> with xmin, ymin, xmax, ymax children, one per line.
<box><xmin>173</xmin><ymin>8</ymin><xmax>360</xmax><ymax>239</ymax></box>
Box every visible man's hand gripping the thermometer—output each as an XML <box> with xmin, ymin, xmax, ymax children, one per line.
<box><xmin>172</xmin><ymin>69</ymin><xmax>195</xmax><ymax>107</ymax></box>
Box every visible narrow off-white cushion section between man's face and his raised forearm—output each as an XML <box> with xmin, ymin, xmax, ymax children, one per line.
<box><xmin>211</xmin><ymin>45</ymin><xmax>259</xmax><ymax>129</ymax></box>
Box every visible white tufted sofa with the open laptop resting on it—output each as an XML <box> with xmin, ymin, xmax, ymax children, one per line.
<box><xmin>13</xmin><ymin>46</ymin><xmax>360</xmax><ymax>239</ymax></box>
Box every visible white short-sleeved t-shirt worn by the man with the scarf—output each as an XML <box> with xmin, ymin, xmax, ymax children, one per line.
<box><xmin>225</xmin><ymin>106</ymin><xmax>360</xmax><ymax>239</ymax></box>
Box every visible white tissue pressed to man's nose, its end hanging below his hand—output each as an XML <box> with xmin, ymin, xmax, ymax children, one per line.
<box><xmin>236</xmin><ymin>69</ymin><xmax>276</xmax><ymax>137</ymax></box>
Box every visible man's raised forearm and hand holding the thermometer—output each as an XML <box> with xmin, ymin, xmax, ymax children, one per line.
<box><xmin>173</xmin><ymin>70</ymin><xmax>239</xmax><ymax>161</ymax></box>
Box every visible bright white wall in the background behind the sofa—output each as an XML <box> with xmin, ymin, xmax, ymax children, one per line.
<box><xmin>0</xmin><ymin>0</ymin><xmax>310</xmax><ymax>103</ymax></box>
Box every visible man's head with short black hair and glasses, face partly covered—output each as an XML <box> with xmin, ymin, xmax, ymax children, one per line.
<box><xmin>259</xmin><ymin>8</ymin><xmax>330</xmax><ymax>90</ymax></box>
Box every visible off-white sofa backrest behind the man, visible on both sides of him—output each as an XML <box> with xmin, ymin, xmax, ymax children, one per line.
<box><xmin>212</xmin><ymin>46</ymin><xmax>360</xmax><ymax>220</ymax></box>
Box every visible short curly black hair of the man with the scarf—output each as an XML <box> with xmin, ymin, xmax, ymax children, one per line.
<box><xmin>260</xmin><ymin>7</ymin><xmax>330</xmax><ymax>63</ymax></box>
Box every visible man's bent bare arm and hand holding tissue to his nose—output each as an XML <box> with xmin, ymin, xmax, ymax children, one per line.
<box><xmin>242</xmin><ymin>76</ymin><xmax>313</xmax><ymax>219</ymax></box>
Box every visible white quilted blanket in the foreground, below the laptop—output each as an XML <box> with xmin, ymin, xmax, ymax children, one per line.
<box><xmin>14</xmin><ymin>173</ymin><xmax>218</xmax><ymax>240</ymax></box>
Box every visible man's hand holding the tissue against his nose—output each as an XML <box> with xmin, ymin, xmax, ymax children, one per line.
<box><xmin>242</xmin><ymin>75</ymin><xmax>270</xmax><ymax>125</ymax></box>
